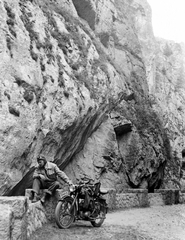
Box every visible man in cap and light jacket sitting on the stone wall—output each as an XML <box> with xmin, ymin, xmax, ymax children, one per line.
<box><xmin>32</xmin><ymin>155</ymin><xmax>72</xmax><ymax>203</ymax></box>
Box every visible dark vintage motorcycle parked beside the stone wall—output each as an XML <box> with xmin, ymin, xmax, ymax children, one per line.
<box><xmin>55</xmin><ymin>181</ymin><xmax>108</xmax><ymax>228</ymax></box>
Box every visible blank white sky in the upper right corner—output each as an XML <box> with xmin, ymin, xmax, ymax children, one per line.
<box><xmin>147</xmin><ymin>0</ymin><xmax>185</xmax><ymax>43</ymax></box>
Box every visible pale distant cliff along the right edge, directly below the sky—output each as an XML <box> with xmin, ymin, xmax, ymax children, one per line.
<box><xmin>149</xmin><ymin>39</ymin><xmax>185</xmax><ymax>189</ymax></box>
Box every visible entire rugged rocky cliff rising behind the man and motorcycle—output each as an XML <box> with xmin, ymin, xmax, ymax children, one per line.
<box><xmin>0</xmin><ymin>0</ymin><xmax>185</xmax><ymax>195</ymax></box>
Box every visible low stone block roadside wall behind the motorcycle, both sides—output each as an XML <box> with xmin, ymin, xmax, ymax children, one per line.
<box><xmin>0</xmin><ymin>189</ymin><xmax>185</xmax><ymax>240</ymax></box>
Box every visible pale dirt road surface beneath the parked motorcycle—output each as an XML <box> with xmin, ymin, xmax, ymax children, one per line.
<box><xmin>32</xmin><ymin>204</ymin><xmax>185</xmax><ymax>240</ymax></box>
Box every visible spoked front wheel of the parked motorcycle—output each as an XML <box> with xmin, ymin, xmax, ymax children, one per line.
<box><xmin>55</xmin><ymin>196</ymin><xmax>75</xmax><ymax>228</ymax></box>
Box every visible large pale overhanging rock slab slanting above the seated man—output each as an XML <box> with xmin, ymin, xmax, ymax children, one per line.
<box><xmin>0</xmin><ymin>1</ymin><xmax>130</xmax><ymax>194</ymax></box>
